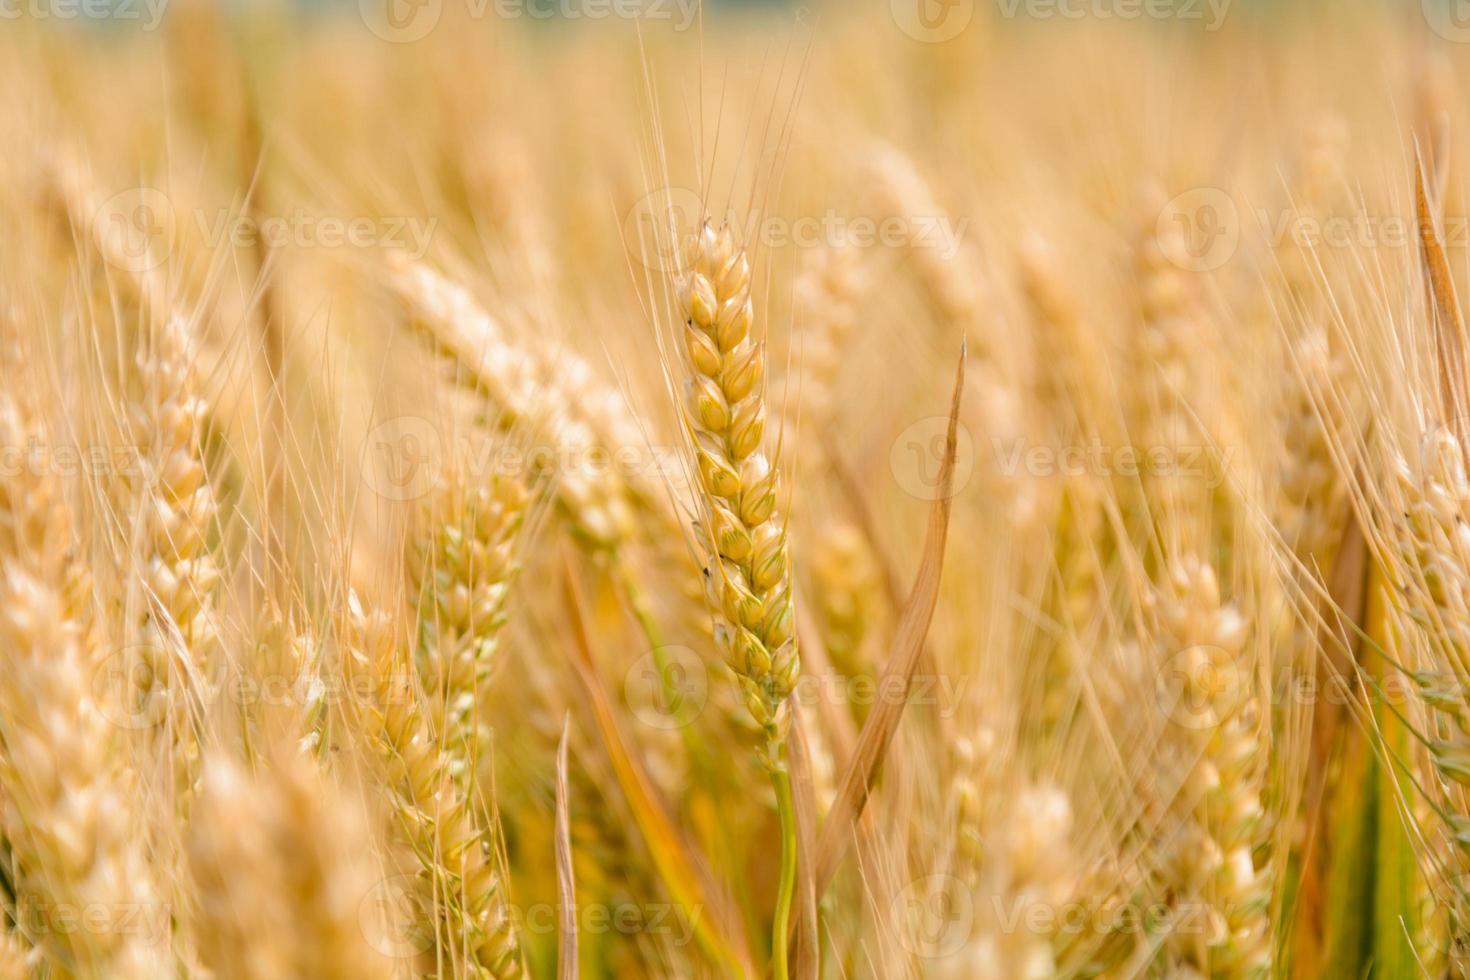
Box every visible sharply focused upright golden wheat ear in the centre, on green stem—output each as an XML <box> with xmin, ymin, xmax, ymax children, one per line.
<box><xmin>679</xmin><ymin>222</ymin><xmax>801</xmax><ymax>767</ymax></box>
